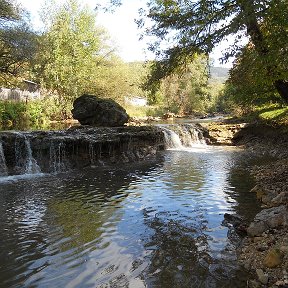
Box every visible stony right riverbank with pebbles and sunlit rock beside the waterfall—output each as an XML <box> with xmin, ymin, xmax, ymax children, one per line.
<box><xmin>205</xmin><ymin>123</ymin><xmax>288</xmax><ymax>288</ymax></box>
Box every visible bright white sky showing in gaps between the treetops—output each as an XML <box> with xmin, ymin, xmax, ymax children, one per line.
<box><xmin>18</xmin><ymin>0</ymin><xmax>231</xmax><ymax>67</ymax></box>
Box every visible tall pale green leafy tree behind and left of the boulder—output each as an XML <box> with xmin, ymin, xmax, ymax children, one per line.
<box><xmin>34</xmin><ymin>0</ymin><xmax>120</xmax><ymax>108</ymax></box>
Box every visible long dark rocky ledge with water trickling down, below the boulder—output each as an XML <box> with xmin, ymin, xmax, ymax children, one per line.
<box><xmin>0</xmin><ymin>126</ymin><xmax>164</xmax><ymax>176</ymax></box>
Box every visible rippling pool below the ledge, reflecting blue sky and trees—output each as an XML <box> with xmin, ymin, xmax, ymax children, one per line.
<box><xmin>0</xmin><ymin>148</ymin><xmax>259</xmax><ymax>288</ymax></box>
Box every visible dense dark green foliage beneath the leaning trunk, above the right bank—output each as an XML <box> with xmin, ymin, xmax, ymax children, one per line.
<box><xmin>220</xmin><ymin>1</ymin><xmax>288</xmax><ymax>112</ymax></box>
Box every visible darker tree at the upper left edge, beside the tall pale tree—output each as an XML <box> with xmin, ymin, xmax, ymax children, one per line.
<box><xmin>0</xmin><ymin>0</ymin><xmax>37</xmax><ymax>82</ymax></box>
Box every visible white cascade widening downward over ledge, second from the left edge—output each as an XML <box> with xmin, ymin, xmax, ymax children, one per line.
<box><xmin>15</xmin><ymin>133</ymin><xmax>41</xmax><ymax>174</ymax></box>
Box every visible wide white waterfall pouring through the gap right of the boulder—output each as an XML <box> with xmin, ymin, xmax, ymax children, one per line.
<box><xmin>160</xmin><ymin>124</ymin><xmax>206</xmax><ymax>150</ymax></box>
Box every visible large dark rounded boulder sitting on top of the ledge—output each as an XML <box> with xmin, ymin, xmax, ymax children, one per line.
<box><xmin>72</xmin><ymin>94</ymin><xmax>129</xmax><ymax>127</ymax></box>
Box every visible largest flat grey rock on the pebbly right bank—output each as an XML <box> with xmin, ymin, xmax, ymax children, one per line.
<box><xmin>247</xmin><ymin>205</ymin><xmax>288</xmax><ymax>236</ymax></box>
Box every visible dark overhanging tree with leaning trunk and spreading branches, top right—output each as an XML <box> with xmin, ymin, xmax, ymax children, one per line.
<box><xmin>112</xmin><ymin>0</ymin><xmax>288</xmax><ymax>103</ymax></box>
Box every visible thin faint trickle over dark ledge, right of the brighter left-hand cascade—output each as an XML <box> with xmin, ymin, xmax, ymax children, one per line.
<box><xmin>49</xmin><ymin>141</ymin><xmax>67</xmax><ymax>173</ymax></box>
